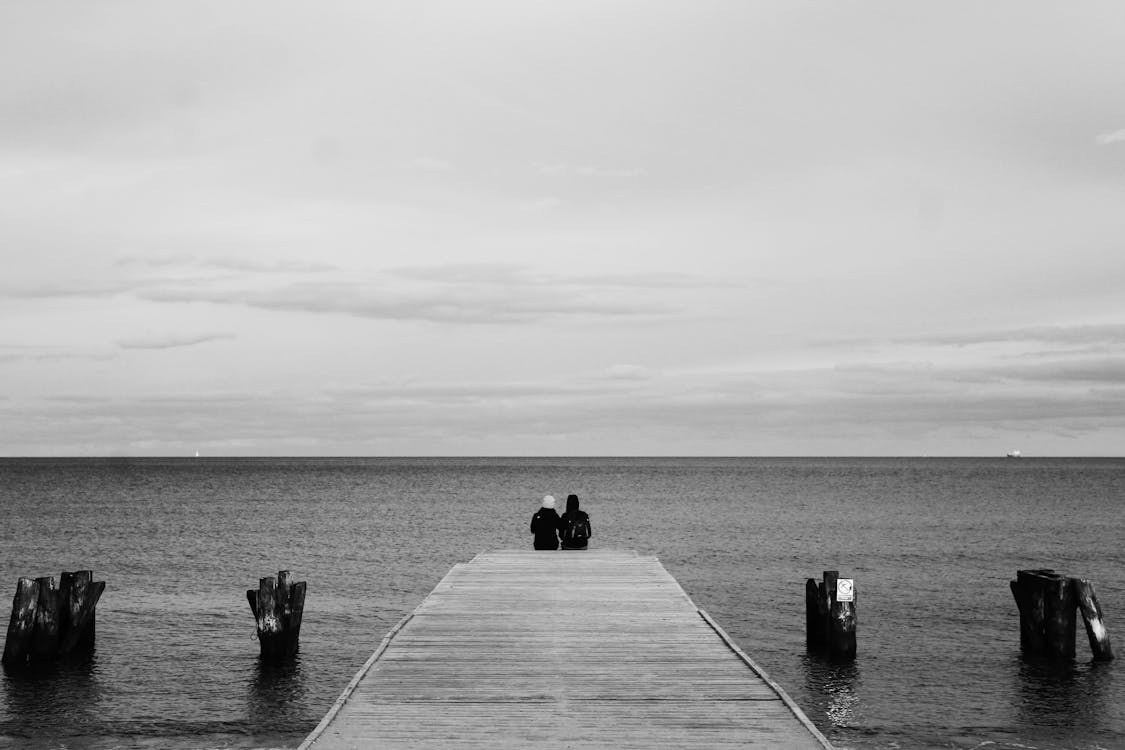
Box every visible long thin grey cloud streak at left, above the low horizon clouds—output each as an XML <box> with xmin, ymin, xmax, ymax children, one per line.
<box><xmin>0</xmin><ymin>263</ymin><xmax>711</xmax><ymax>323</ymax></box>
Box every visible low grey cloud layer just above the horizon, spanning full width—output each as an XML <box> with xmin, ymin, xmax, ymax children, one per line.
<box><xmin>8</xmin><ymin>344</ymin><xmax>1125</xmax><ymax>454</ymax></box>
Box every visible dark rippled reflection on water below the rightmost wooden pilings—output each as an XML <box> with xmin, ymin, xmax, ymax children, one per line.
<box><xmin>1013</xmin><ymin>654</ymin><xmax>1113</xmax><ymax>730</ymax></box>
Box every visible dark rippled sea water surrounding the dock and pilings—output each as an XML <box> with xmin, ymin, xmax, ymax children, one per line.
<box><xmin>0</xmin><ymin>459</ymin><xmax>1125</xmax><ymax>750</ymax></box>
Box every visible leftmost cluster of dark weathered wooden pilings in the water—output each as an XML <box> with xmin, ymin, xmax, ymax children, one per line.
<box><xmin>3</xmin><ymin>570</ymin><xmax>106</xmax><ymax>667</ymax></box>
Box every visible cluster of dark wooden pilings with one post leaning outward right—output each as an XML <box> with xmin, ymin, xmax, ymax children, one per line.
<box><xmin>1010</xmin><ymin>569</ymin><xmax>1114</xmax><ymax>661</ymax></box>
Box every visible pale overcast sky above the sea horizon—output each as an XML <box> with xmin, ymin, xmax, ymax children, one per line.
<box><xmin>0</xmin><ymin>0</ymin><xmax>1125</xmax><ymax>455</ymax></box>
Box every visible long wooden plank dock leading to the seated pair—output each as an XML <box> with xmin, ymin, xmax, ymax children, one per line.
<box><xmin>298</xmin><ymin>550</ymin><xmax>831</xmax><ymax>750</ymax></box>
